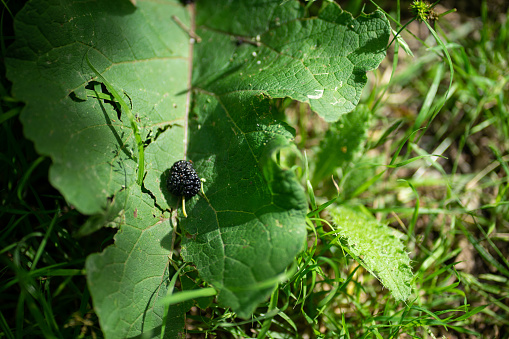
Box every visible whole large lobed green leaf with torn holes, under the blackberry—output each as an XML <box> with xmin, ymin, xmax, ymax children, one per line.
<box><xmin>6</xmin><ymin>0</ymin><xmax>389</xmax><ymax>337</ymax></box>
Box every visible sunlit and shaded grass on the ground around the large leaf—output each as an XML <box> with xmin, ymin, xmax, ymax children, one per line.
<box><xmin>0</xmin><ymin>1</ymin><xmax>509</xmax><ymax>338</ymax></box>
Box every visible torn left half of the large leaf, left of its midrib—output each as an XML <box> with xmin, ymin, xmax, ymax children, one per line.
<box><xmin>6</xmin><ymin>0</ymin><xmax>190</xmax><ymax>338</ymax></box>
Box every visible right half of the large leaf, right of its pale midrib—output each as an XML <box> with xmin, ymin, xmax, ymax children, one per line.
<box><xmin>182</xmin><ymin>1</ymin><xmax>389</xmax><ymax>317</ymax></box>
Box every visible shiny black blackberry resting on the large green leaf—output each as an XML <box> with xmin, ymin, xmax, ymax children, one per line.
<box><xmin>167</xmin><ymin>160</ymin><xmax>201</xmax><ymax>198</ymax></box>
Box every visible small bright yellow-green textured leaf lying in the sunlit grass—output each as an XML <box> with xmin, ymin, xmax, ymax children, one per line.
<box><xmin>330</xmin><ymin>207</ymin><xmax>413</xmax><ymax>301</ymax></box>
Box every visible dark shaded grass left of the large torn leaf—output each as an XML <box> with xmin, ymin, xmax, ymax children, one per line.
<box><xmin>0</xmin><ymin>117</ymin><xmax>105</xmax><ymax>338</ymax></box>
